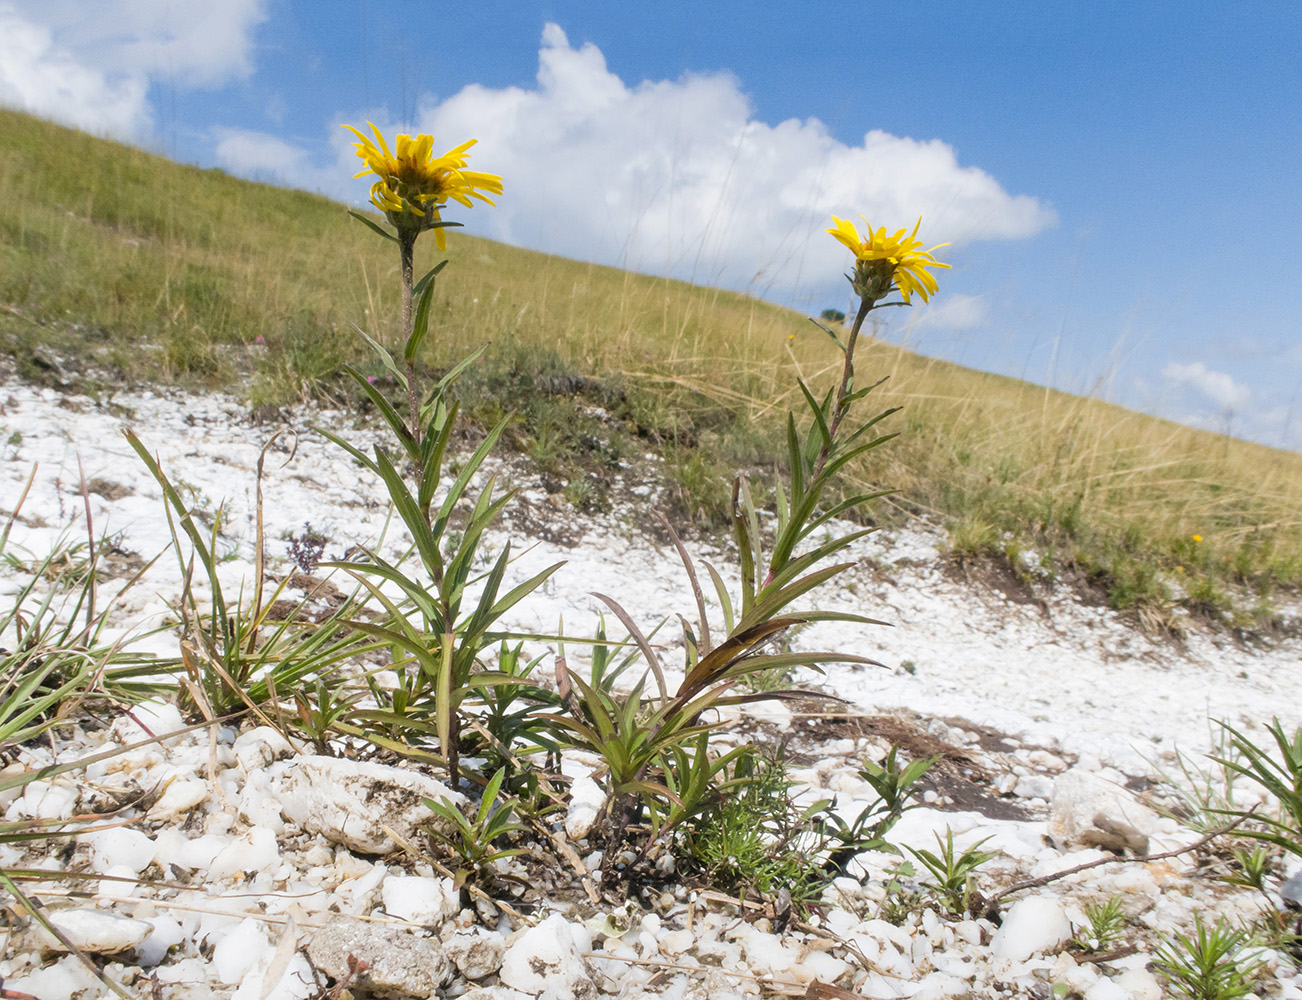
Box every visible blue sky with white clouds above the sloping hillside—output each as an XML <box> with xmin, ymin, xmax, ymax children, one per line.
<box><xmin>0</xmin><ymin>0</ymin><xmax>1302</xmax><ymax>449</ymax></box>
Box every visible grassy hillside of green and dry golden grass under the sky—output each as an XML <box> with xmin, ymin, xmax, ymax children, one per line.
<box><xmin>0</xmin><ymin>111</ymin><xmax>1302</xmax><ymax>626</ymax></box>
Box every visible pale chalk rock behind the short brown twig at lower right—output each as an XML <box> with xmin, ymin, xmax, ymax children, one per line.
<box><xmin>1049</xmin><ymin>767</ymin><xmax>1157</xmax><ymax>854</ymax></box>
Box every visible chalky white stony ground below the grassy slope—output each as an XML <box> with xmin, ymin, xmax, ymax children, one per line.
<box><xmin>0</xmin><ymin>382</ymin><xmax>1302</xmax><ymax>1000</ymax></box>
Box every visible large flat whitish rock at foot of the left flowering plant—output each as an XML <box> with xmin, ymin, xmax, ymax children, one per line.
<box><xmin>273</xmin><ymin>757</ymin><xmax>465</xmax><ymax>854</ymax></box>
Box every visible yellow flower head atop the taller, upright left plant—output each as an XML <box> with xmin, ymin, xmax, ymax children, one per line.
<box><xmin>342</xmin><ymin>122</ymin><xmax>501</xmax><ymax>250</ymax></box>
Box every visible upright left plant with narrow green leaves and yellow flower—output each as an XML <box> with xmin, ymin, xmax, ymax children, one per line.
<box><xmin>319</xmin><ymin>125</ymin><xmax>561</xmax><ymax>785</ymax></box>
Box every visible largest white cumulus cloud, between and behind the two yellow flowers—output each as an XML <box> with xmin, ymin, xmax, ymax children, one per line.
<box><xmin>361</xmin><ymin>25</ymin><xmax>1056</xmax><ymax>294</ymax></box>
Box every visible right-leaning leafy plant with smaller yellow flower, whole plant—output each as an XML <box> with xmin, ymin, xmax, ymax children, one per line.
<box><xmin>552</xmin><ymin>216</ymin><xmax>948</xmax><ymax>878</ymax></box>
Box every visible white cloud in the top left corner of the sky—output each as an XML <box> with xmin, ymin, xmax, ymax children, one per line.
<box><xmin>0</xmin><ymin>0</ymin><xmax>266</xmax><ymax>138</ymax></box>
